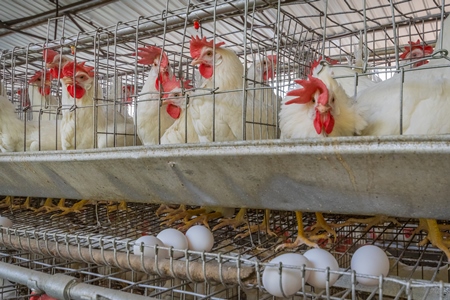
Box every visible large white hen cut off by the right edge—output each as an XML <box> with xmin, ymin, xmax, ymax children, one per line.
<box><xmin>357</xmin><ymin>18</ymin><xmax>450</xmax><ymax>260</ymax></box>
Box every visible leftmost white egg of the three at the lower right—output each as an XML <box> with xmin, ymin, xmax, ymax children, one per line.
<box><xmin>262</xmin><ymin>253</ymin><xmax>311</xmax><ymax>297</ymax></box>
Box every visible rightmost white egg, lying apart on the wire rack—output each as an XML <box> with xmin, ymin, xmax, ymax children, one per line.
<box><xmin>351</xmin><ymin>245</ymin><xmax>389</xmax><ymax>285</ymax></box>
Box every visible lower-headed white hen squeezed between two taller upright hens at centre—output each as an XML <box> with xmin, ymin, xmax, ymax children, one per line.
<box><xmin>161</xmin><ymin>76</ymin><xmax>199</xmax><ymax>144</ymax></box>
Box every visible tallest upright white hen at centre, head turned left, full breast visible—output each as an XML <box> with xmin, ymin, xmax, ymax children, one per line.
<box><xmin>189</xmin><ymin>36</ymin><xmax>244</xmax><ymax>143</ymax></box>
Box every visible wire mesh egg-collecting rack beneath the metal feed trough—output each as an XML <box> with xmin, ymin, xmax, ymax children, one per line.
<box><xmin>0</xmin><ymin>197</ymin><xmax>449</xmax><ymax>299</ymax></box>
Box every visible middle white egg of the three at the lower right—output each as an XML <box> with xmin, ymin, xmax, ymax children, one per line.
<box><xmin>303</xmin><ymin>248</ymin><xmax>339</xmax><ymax>289</ymax></box>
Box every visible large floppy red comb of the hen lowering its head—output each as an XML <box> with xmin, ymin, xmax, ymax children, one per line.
<box><xmin>286</xmin><ymin>75</ymin><xmax>328</xmax><ymax>105</ymax></box>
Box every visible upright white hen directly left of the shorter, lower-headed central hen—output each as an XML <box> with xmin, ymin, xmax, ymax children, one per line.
<box><xmin>136</xmin><ymin>46</ymin><xmax>174</xmax><ymax>145</ymax></box>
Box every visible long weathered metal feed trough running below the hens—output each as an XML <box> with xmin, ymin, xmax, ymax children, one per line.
<box><xmin>0</xmin><ymin>135</ymin><xmax>450</xmax><ymax>219</ymax></box>
